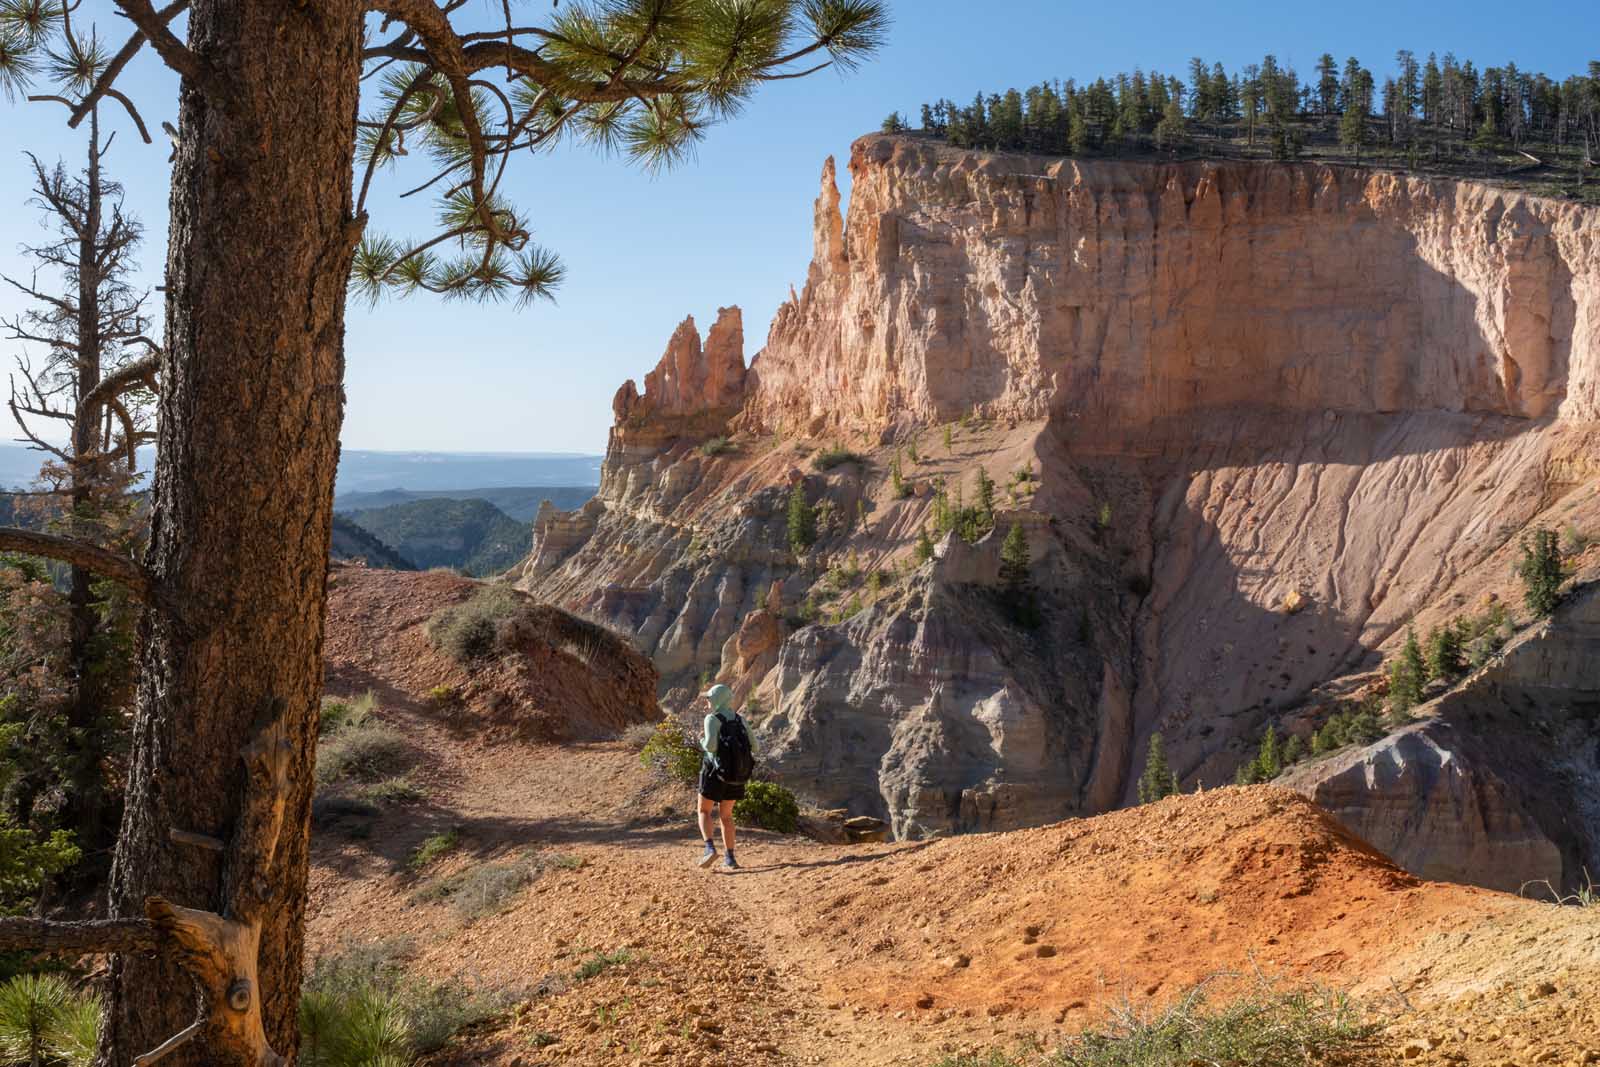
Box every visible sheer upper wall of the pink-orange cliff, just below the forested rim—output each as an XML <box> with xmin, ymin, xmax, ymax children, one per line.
<box><xmin>750</xmin><ymin>136</ymin><xmax>1600</xmax><ymax>427</ymax></box>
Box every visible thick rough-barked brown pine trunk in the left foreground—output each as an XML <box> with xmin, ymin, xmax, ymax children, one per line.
<box><xmin>99</xmin><ymin>0</ymin><xmax>362</xmax><ymax>1067</ymax></box>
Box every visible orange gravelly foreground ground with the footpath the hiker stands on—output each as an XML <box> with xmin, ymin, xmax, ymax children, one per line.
<box><xmin>310</xmin><ymin>593</ymin><xmax>1600</xmax><ymax>1067</ymax></box>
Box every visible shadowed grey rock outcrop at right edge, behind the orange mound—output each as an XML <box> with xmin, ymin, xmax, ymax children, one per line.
<box><xmin>1288</xmin><ymin>584</ymin><xmax>1600</xmax><ymax>893</ymax></box>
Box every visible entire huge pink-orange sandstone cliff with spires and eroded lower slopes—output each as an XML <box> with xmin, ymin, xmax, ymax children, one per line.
<box><xmin>520</xmin><ymin>138</ymin><xmax>1600</xmax><ymax>877</ymax></box>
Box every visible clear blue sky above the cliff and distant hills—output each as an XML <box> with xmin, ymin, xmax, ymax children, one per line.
<box><xmin>0</xmin><ymin>0</ymin><xmax>1600</xmax><ymax>451</ymax></box>
